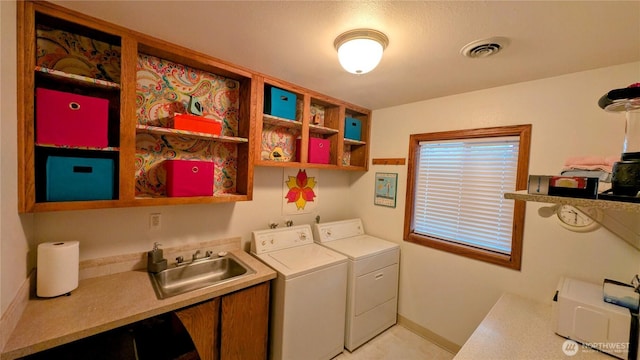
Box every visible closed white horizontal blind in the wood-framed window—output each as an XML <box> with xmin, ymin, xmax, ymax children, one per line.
<box><xmin>413</xmin><ymin>136</ymin><xmax>519</xmax><ymax>254</ymax></box>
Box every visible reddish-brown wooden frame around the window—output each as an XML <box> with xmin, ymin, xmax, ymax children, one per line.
<box><xmin>404</xmin><ymin>124</ymin><xmax>531</xmax><ymax>270</ymax></box>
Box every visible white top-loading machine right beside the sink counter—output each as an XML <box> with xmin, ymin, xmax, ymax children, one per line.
<box><xmin>251</xmin><ymin>225</ymin><xmax>347</xmax><ymax>360</ymax></box>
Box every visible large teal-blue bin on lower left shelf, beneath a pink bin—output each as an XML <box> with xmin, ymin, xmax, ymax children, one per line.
<box><xmin>46</xmin><ymin>156</ymin><xmax>114</xmax><ymax>201</ymax></box>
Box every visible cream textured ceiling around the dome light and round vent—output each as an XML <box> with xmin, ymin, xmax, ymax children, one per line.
<box><xmin>53</xmin><ymin>1</ymin><xmax>640</xmax><ymax>109</ymax></box>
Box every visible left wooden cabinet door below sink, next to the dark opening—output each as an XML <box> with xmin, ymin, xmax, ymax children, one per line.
<box><xmin>175</xmin><ymin>298</ymin><xmax>220</xmax><ymax>360</ymax></box>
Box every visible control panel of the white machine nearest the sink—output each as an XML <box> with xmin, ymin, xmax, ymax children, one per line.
<box><xmin>251</xmin><ymin>225</ymin><xmax>313</xmax><ymax>255</ymax></box>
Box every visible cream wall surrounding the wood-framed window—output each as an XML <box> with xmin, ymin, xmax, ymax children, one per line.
<box><xmin>352</xmin><ymin>63</ymin><xmax>640</xmax><ymax>345</ymax></box>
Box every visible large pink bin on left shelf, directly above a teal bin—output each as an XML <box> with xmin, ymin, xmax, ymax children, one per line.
<box><xmin>36</xmin><ymin>88</ymin><xmax>109</xmax><ymax>148</ymax></box>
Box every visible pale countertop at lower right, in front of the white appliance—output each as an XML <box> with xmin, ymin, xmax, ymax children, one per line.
<box><xmin>454</xmin><ymin>293</ymin><xmax>615</xmax><ymax>360</ymax></box>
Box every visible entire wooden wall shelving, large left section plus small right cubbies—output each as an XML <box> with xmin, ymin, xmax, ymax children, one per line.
<box><xmin>17</xmin><ymin>1</ymin><xmax>371</xmax><ymax>212</ymax></box>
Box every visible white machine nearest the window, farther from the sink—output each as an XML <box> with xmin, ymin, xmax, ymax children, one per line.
<box><xmin>314</xmin><ymin>219</ymin><xmax>400</xmax><ymax>351</ymax></box>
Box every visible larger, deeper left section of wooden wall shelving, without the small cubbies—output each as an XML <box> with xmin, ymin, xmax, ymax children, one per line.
<box><xmin>17</xmin><ymin>1</ymin><xmax>256</xmax><ymax>212</ymax></box>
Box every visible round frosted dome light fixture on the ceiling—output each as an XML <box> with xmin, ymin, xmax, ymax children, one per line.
<box><xmin>333</xmin><ymin>29</ymin><xmax>389</xmax><ymax>75</ymax></box>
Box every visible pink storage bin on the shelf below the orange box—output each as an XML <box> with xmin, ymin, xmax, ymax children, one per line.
<box><xmin>164</xmin><ymin>160</ymin><xmax>213</xmax><ymax>197</ymax></box>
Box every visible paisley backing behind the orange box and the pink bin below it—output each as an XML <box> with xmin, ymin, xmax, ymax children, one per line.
<box><xmin>135</xmin><ymin>54</ymin><xmax>240</xmax><ymax>197</ymax></box>
